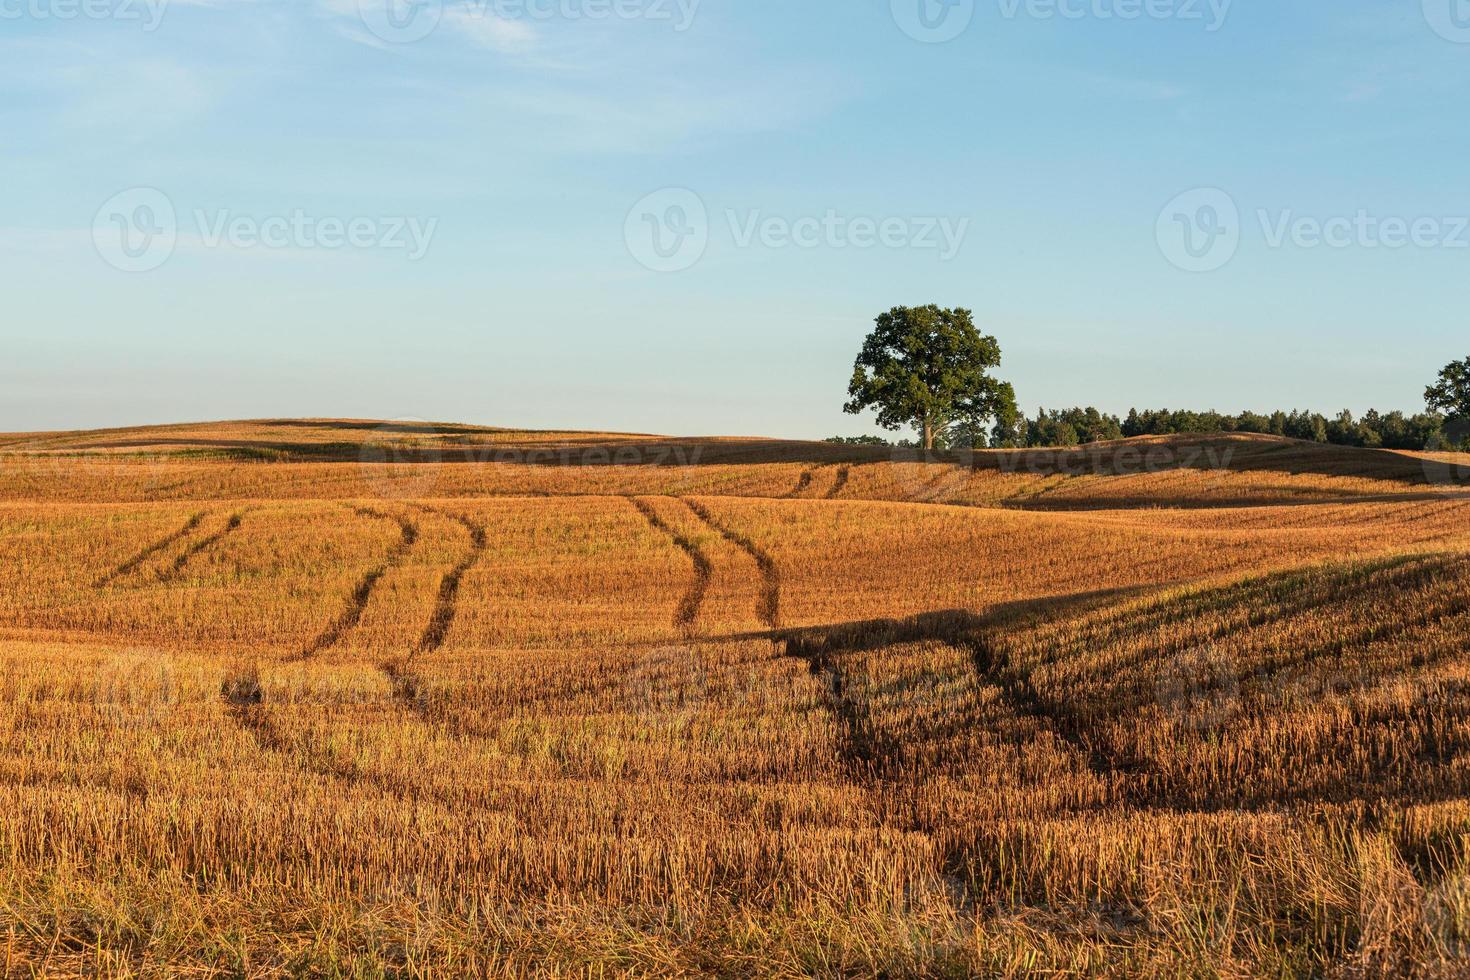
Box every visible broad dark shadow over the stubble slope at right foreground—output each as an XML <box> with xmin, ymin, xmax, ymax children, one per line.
<box><xmin>775</xmin><ymin>554</ymin><xmax>1470</xmax><ymax>813</ymax></box>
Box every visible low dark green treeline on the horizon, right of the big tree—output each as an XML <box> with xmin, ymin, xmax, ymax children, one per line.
<box><xmin>828</xmin><ymin>408</ymin><xmax>1461</xmax><ymax>450</ymax></box>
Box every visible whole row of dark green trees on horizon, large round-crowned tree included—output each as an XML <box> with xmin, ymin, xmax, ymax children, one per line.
<box><xmin>832</xmin><ymin>306</ymin><xmax>1470</xmax><ymax>450</ymax></box>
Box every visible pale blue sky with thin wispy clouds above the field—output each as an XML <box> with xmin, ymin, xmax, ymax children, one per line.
<box><xmin>0</xmin><ymin>0</ymin><xmax>1470</xmax><ymax>436</ymax></box>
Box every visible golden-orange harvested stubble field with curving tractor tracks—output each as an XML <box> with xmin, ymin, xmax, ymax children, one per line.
<box><xmin>0</xmin><ymin>420</ymin><xmax>1470</xmax><ymax>977</ymax></box>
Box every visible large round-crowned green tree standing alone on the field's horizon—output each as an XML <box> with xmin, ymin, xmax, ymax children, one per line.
<box><xmin>844</xmin><ymin>306</ymin><xmax>1016</xmax><ymax>450</ymax></box>
